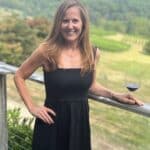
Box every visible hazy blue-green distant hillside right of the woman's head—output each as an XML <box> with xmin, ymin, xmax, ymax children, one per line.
<box><xmin>84</xmin><ymin>0</ymin><xmax>150</xmax><ymax>20</ymax></box>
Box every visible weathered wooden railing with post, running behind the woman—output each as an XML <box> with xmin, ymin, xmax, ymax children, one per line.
<box><xmin>0</xmin><ymin>62</ymin><xmax>150</xmax><ymax>150</ymax></box>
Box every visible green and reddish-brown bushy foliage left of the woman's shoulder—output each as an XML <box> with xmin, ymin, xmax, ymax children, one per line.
<box><xmin>0</xmin><ymin>15</ymin><xmax>49</xmax><ymax>66</ymax></box>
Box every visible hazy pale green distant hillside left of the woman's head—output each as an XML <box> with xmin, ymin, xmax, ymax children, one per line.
<box><xmin>0</xmin><ymin>0</ymin><xmax>62</xmax><ymax>18</ymax></box>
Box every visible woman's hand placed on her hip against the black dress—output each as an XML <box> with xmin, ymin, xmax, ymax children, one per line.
<box><xmin>29</xmin><ymin>105</ymin><xmax>56</xmax><ymax>124</ymax></box>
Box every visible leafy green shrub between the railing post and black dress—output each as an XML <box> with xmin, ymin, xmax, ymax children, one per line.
<box><xmin>7</xmin><ymin>108</ymin><xmax>33</xmax><ymax>150</ymax></box>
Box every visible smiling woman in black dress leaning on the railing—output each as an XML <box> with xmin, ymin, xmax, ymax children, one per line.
<box><xmin>14</xmin><ymin>1</ymin><xmax>142</xmax><ymax>150</ymax></box>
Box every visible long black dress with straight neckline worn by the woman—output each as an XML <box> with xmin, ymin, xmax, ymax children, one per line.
<box><xmin>32</xmin><ymin>61</ymin><xmax>93</xmax><ymax>150</ymax></box>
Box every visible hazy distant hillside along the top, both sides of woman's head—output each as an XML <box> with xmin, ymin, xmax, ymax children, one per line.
<box><xmin>0</xmin><ymin>0</ymin><xmax>150</xmax><ymax>22</ymax></box>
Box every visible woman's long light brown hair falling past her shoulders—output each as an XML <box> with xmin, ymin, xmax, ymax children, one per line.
<box><xmin>45</xmin><ymin>0</ymin><xmax>94</xmax><ymax>73</ymax></box>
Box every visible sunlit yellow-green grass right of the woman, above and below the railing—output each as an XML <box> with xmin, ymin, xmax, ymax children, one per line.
<box><xmin>90</xmin><ymin>34</ymin><xmax>150</xmax><ymax>150</ymax></box>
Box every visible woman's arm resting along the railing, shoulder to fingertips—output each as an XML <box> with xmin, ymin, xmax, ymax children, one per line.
<box><xmin>89</xmin><ymin>49</ymin><xmax>143</xmax><ymax>105</ymax></box>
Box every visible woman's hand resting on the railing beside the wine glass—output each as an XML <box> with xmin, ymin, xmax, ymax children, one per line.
<box><xmin>113</xmin><ymin>93</ymin><xmax>144</xmax><ymax>106</ymax></box>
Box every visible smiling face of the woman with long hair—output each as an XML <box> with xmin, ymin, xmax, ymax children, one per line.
<box><xmin>60</xmin><ymin>6</ymin><xmax>83</xmax><ymax>43</ymax></box>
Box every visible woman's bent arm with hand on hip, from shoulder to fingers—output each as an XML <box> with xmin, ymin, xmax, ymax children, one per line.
<box><xmin>14</xmin><ymin>44</ymin><xmax>55</xmax><ymax>123</ymax></box>
